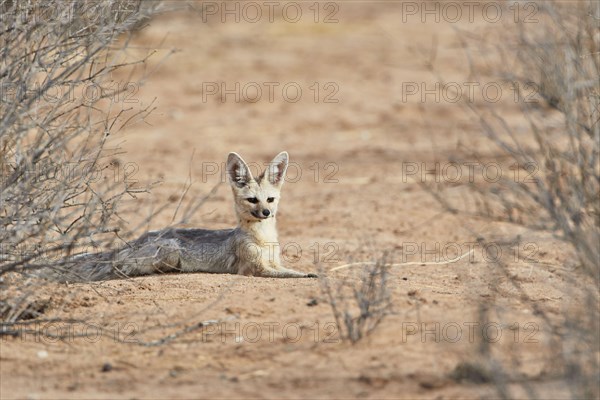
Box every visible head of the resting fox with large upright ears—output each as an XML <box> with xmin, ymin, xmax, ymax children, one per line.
<box><xmin>227</xmin><ymin>151</ymin><xmax>289</xmax><ymax>221</ymax></box>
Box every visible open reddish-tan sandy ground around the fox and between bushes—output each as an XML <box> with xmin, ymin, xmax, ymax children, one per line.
<box><xmin>0</xmin><ymin>2</ymin><xmax>592</xmax><ymax>399</ymax></box>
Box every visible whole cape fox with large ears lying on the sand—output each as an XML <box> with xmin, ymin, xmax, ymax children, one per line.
<box><xmin>61</xmin><ymin>151</ymin><xmax>316</xmax><ymax>281</ymax></box>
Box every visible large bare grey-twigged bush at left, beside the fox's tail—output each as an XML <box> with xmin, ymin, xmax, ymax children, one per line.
<box><xmin>0</xmin><ymin>0</ymin><xmax>169</xmax><ymax>323</ymax></box>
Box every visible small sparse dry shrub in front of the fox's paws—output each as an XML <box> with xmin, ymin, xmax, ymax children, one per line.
<box><xmin>319</xmin><ymin>253</ymin><xmax>392</xmax><ymax>344</ymax></box>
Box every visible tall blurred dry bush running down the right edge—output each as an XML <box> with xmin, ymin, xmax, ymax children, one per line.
<box><xmin>436</xmin><ymin>2</ymin><xmax>600</xmax><ymax>398</ymax></box>
